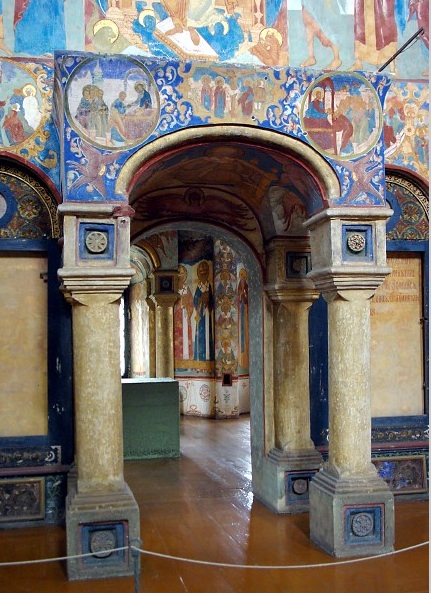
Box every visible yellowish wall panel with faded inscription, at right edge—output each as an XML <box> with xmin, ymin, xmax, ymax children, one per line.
<box><xmin>371</xmin><ymin>252</ymin><xmax>424</xmax><ymax>417</ymax></box>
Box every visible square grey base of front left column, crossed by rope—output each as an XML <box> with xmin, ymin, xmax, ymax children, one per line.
<box><xmin>66</xmin><ymin>484</ymin><xmax>140</xmax><ymax>581</ymax></box>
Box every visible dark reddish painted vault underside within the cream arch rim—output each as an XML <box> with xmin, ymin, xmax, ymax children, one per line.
<box><xmin>129</xmin><ymin>142</ymin><xmax>323</xmax><ymax>248</ymax></box>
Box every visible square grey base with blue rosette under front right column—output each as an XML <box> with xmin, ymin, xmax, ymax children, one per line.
<box><xmin>310</xmin><ymin>468</ymin><xmax>394</xmax><ymax>558</ymax></box>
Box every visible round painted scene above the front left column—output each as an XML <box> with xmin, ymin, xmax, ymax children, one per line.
<box><xmin>66</xmin><ymin>56</ymin><xmax>160</xmax><ymax>150</ymax></box>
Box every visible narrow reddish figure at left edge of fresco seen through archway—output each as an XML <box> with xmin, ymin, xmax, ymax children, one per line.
<box><xmin>174</xmin><ymin>265</ymin><xmax>193</xmax><ymax>360</ymax></box>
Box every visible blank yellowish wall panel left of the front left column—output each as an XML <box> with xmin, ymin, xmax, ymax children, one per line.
<box><xmin>0</xmin><ymin>252</ymin><xmax>48</xmax><ymax>437</ymax></box>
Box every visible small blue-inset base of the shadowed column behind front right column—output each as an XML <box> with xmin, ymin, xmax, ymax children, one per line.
<box><xmin>268</xmin><ymin>449</ymin><xmax>322</xmax><ymax>515</ymax></box>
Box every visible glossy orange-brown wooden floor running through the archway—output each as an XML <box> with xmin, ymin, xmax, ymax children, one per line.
<box><xmin>0</xmin><ymin>416</ymin><xmax>429</xmax><ymax>593</ymax></box>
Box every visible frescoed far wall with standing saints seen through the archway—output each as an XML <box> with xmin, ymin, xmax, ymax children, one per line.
<box><xmin>174</xmin><ymin>231</ymin><xmax>250</xmax><ymax>418</ymax></box>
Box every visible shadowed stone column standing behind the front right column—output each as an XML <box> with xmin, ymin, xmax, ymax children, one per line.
<box><xmin>265</xmin><ymin>238</ymin><xmax>322</xmax><ymax>513</ymax></box>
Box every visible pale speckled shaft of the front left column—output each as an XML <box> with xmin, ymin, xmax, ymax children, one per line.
<box><xmin>72</xmin><ymin>294</ymin><xmax>124</xmax><ymax>493</ymax></box>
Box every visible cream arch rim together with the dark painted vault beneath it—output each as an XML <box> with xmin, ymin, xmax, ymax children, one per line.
<box><xmin>116</xmin><ymin>126</ymin><xmax>340</xmax><ymax>251</ymax></box>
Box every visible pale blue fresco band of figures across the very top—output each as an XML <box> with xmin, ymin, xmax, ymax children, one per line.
<box><xmin>0</xmin><ymin>0</ymin><xmax>429</xmax><ymax>79</ymax></box>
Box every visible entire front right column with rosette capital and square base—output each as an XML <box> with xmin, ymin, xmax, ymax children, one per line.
<box><xmin>306</xmin><ymin>207</ymin><xmax>394</xmax><ymax>557</ymax></box>
